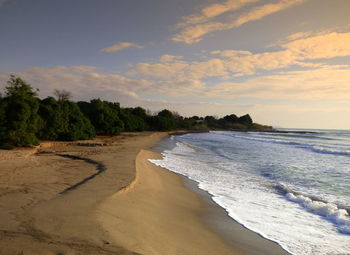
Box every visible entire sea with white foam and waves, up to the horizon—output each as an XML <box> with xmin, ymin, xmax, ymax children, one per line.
<box><xmin>151</xmin><ymin>130</ymin><xmax>350</xmax><ymax>255</ymax></box>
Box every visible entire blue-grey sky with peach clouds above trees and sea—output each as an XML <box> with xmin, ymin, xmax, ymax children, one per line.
<box><xmin>0</xmin><ymin>0</ymin><xmax>350</xmax><ymax>129</ymax></box>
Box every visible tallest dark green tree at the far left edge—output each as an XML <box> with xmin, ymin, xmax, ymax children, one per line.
<box><xmin>0</xmin><ymin>75</ymin><xmax>41</xmax><ymax>147</ymax></box>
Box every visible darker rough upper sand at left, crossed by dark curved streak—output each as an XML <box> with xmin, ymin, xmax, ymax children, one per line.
<box><xmin>0</xmin><ymin>132</ymin><xmax>167</xmax><ymax>255</ymax></box>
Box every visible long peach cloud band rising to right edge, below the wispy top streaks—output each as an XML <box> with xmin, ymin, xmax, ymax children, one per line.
<box><xmin>127</xmin><ymin>32</ymin><xmax>350</xmax><ymax>81</ymax></box>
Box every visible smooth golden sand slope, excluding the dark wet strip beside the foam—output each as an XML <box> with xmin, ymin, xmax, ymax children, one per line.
<box><xmin>98</xmin><ymin>150</ymin><xmax>239</xmax><ymax>255</ymax></box>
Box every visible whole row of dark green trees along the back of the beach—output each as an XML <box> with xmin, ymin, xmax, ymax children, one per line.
<box><xmin>0</xmin><ymin>75</ymin><xmax>271</xmax><ymax>149</ymax></box>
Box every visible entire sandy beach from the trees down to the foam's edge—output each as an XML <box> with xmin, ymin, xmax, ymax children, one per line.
<box><xmin>0</xmin><ymin>132</ymin><xmax>287</xmax><ymax>255</ymax></box>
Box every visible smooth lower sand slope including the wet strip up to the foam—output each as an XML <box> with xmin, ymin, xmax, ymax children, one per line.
<box><xmin>99</xmin><ymin>140</ymin><xmax>289</xmax><ymax>255</ymax></box>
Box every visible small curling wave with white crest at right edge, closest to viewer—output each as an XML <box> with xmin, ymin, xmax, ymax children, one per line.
<box><xmin>275</xmin><ymin>184</ymin><xmax>350</xmax><ymax>235</ymax></box>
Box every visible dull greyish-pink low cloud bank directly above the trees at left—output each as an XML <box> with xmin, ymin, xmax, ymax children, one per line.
<box><xmin>0</xmin><ymin>66</ymin><xmax>149</xmax><ymax>105</ymax></box>
